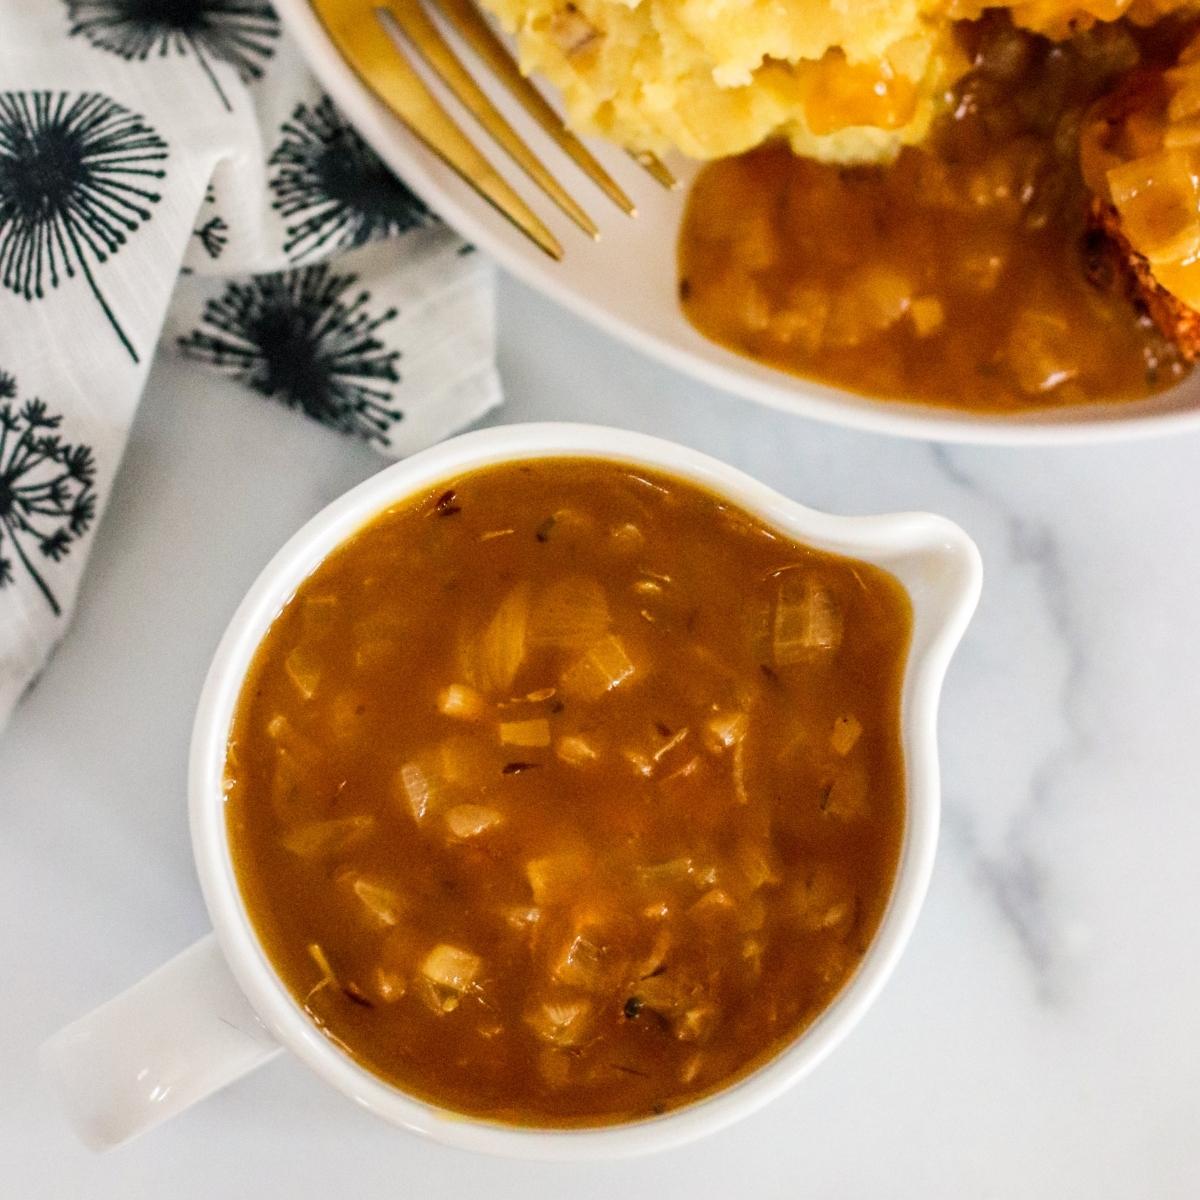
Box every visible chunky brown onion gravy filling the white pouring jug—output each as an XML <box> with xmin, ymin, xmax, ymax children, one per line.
<box><xmin>228</xmin><ymin>460</ymin><xmax>911</xmax><ymax>1126</ymax></box>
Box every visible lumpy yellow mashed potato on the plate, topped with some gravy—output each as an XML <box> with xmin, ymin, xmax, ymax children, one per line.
<box><xmin>485</xmin><ymin>0</ymin><xmax>1196</xmax><ymax>162</ymax></box>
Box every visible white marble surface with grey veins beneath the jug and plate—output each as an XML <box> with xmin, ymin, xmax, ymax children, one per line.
<box><xmin>0</xmin><ymin>276</ymin><xmax>1200</xmax><ymax>1200</ymax></box>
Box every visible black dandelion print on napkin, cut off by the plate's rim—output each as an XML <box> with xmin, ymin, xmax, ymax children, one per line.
<box><xmin>269</xmin><ymin>96</ymin><xmax>437</xmax><ymax>260</ymax></box>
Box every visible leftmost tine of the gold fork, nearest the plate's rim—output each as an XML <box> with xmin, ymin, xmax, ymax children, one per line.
<box><xmin>313</xmin><ymin>0</ymin><xmax>563</xmax><ymax>259</ymax></box>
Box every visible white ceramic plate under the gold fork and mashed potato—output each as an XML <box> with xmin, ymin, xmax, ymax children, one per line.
<box><xmin>276</xmin><ymin>0</ymin><xmax>1200</xmax><ymax>444</ymax></box>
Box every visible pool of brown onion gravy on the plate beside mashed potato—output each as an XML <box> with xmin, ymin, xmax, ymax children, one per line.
<box><xmin>679</xmin><ymin>14</ymin><xmax>1188</xmax><ymax>413</ymax></box>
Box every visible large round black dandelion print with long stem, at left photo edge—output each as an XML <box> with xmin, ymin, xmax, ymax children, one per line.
<box><xmin>0</xmin><ymin>91</ymin><xmax>167</xmax><ymax>362</ymax></box>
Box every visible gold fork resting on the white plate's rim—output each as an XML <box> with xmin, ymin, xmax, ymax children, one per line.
<box><xmin>312</xmin><ymin>0</ymin><xmax>676</xmax><ymax>259</ymax></box>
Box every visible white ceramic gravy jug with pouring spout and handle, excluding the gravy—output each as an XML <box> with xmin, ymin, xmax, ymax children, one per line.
<box><xmin>47</xmin><ymin>425</ymin><xmax>980</xmax><ymax>1159</ymax></box>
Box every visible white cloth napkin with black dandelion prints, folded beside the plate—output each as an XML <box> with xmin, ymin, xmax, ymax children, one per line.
<box><xmin>0</xmin><ymin>0</ymin><xmax>500</xmax><ymax>727</ymax></box>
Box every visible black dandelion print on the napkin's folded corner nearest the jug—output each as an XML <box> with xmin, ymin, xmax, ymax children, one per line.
<box><xmin>179</xmin><ymin>264</ymin><xmax>402</xmax><ymax>442</ymax></box>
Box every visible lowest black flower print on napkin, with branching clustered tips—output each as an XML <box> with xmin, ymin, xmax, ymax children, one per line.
<box><xmin>0</xmin><ymin>371</ymin><xmax>96</xmax><ymax>616</ymax></box>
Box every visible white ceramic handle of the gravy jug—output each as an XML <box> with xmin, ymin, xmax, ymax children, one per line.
<box><xmin>40</xmin><ymin>934</ymin><xmax>282</xmax><ymax>1151</ymax></box>
